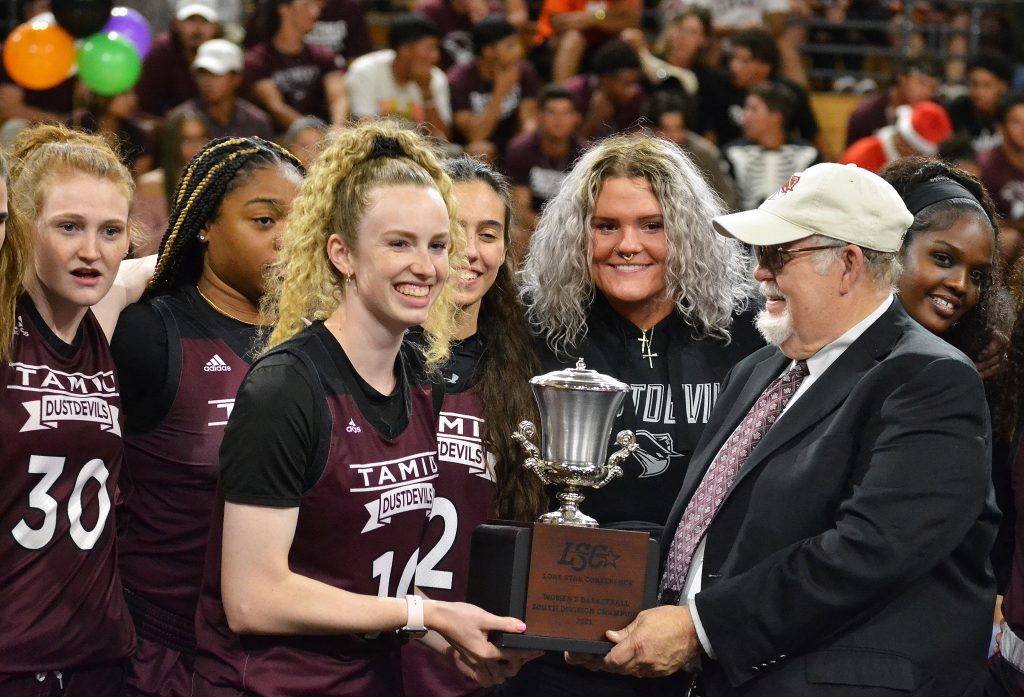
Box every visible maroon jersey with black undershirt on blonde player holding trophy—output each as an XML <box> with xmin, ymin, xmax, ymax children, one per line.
<box><xmin>196</xmin><ymin>321</ymin><xmax>437</xmax><ymax>697</ymax></box>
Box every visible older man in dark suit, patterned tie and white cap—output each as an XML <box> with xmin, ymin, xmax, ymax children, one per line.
<box><xmin>570</xmin><ymin>164</ymin><xmax>998</xmax><ymax>697</ymax></box>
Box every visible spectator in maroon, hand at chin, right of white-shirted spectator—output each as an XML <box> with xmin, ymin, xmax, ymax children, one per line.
<box><xmin>447</xmin><ymin>14</ymin><xmax>540</xmax><ymax>162</ymax></box>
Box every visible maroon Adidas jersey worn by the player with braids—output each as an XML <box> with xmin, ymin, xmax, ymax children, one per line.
<box><xmin>118</xmin><ymin>288</ymin><xmax>256</xmax><ymax>631</ymax></box>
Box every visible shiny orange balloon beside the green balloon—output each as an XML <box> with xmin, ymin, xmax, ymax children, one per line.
<box><xmin>3</xmin><ymin>21</ymin><xmax>75</xmax><ymax>89</ymax></box>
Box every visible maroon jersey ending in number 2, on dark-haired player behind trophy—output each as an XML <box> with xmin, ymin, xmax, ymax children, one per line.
<box><xmin>402</xmin><ymin>337</ymin><xmax>495</xmax><ymax>697</ymax></box>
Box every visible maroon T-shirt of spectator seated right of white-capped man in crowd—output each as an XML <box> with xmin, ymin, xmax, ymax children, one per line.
<box><xmin>245</xmin><ymin>42</ymin><xmax>344</xmax><ymax>120</ymax></box>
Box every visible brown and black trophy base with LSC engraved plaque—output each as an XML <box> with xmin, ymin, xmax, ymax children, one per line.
<box><xmin>467</xmin><ymin>523</ymin><xmax>658</xmax><ymax>655</ymax></box>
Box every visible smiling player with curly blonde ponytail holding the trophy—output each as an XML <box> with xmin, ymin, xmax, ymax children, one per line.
<box><xmin>194</xmin><ymin>123</ymin><xmax>525</xmax><ymax>697</ymax></box>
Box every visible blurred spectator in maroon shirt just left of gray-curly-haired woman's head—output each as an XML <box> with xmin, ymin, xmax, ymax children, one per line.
<box><xmin>505</xmin><ymin>85</ymin><xmax>586</xmax><ymax>236</ymax></box>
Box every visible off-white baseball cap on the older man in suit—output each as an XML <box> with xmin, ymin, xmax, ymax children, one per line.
<box><xmin>712</xmin><ymin>163</ymin><xmax>913</xmax><ymax>252</ymax></box>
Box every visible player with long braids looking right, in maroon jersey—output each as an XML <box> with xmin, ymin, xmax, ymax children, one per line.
<box><xmin>112</xmin><ymin>137</ymin><xmax>304</xmax><ymax>697</ymax></box>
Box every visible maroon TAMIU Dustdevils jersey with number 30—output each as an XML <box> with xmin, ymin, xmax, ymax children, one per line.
<box><xmin>0</xmin><ymin>297</ymin><xmax>135</xmax><ymax>674</ymax></box>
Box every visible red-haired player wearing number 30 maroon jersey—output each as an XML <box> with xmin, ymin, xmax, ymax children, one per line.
<box><xmin>0</xmin><ymin>126</ymin><xmax>135</xmax><ymax>697</ymax></box>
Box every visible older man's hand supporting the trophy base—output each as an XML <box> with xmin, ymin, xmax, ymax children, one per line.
<box><xmin>565</xmin><ymin>605</ymin><xmax>700</xmax><ymax>678</ymax></box>
